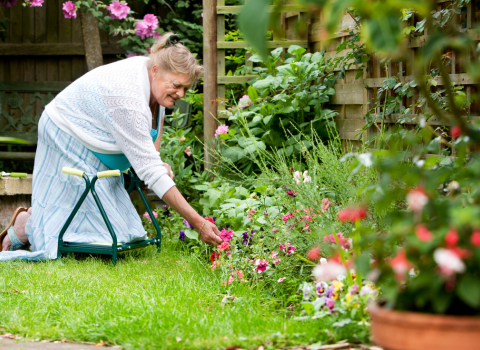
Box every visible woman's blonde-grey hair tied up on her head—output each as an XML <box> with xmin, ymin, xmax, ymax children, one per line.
<box><xmin>147</xmin><ymin>32</ymin><xmax>203</xmax><ymax>84</ymax></box>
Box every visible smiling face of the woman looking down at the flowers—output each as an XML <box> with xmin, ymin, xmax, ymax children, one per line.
<box><xmin>149</xmin><ymin>65</ymin><xmax>190</xmax><ymax>107</ymax></box>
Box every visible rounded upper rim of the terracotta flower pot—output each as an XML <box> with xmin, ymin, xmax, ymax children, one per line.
<box><xmin>368</xmin><ymin>303</ymin><xmax>480</xmax><ymax>330</ymax></box>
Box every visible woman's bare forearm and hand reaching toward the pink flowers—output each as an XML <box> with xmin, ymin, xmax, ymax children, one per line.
<box><xmin>162</xmin><ymin>186</ymin><xmax>222</xmax><ymax>245</ymax></box>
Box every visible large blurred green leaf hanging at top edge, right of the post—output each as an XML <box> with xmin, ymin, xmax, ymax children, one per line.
<box><xmin>238</xmin><ymin>0</ymin><xmax>271</xmax><ymax>60</ymax></box>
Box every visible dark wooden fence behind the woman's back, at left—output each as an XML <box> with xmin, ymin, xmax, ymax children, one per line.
<box><xmin>0</xmin><ymin>0</ymin><xmax>124</xmax><ymax>159</ymax></box>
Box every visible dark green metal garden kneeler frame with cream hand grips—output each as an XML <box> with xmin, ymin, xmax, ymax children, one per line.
<box><xmin>57</xmin><ymin>168</ymin><xmax>162</xmax><ymax>265</ymax></box>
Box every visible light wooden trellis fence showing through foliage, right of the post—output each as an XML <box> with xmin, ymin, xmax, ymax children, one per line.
<box><xmin>204</xmin><ymin>0</ymin><xmax>480</xmax><ymax>146</ymax></box>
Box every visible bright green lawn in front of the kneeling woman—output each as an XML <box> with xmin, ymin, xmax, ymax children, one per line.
<box><xmin>0</xmin><ymin>242</ymin><xmax>338</xmax><ymax>349</ymax></box>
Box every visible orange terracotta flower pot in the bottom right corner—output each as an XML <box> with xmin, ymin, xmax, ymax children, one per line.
<box><xmin>369</xmin><ymin>304</ymin><xmax>480</xmax><ymax>350</ymax></box>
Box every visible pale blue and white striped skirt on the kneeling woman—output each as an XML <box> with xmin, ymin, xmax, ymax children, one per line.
<box><xmin>0</xmin><ymin>112</ymin><xmax>147</xmax><ymax>261</ymax></box>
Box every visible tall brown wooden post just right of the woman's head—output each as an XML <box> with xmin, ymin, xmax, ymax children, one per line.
<box><xmin>203</xmin><ymin>0</ymin><xmax>217</xmax><ymax>168</ymax></box>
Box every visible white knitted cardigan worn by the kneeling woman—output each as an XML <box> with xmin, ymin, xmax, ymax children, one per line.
<box><xmin>45</xmin><ymin>57</ymin><xmax>175</xmax><ymax>198</ymax></box>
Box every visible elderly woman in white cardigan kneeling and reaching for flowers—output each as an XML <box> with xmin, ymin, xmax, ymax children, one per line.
<box><xmin>0</xmin><ymin>33</ymin><xmax>221</xmax><ymax>260</ymax></box>
